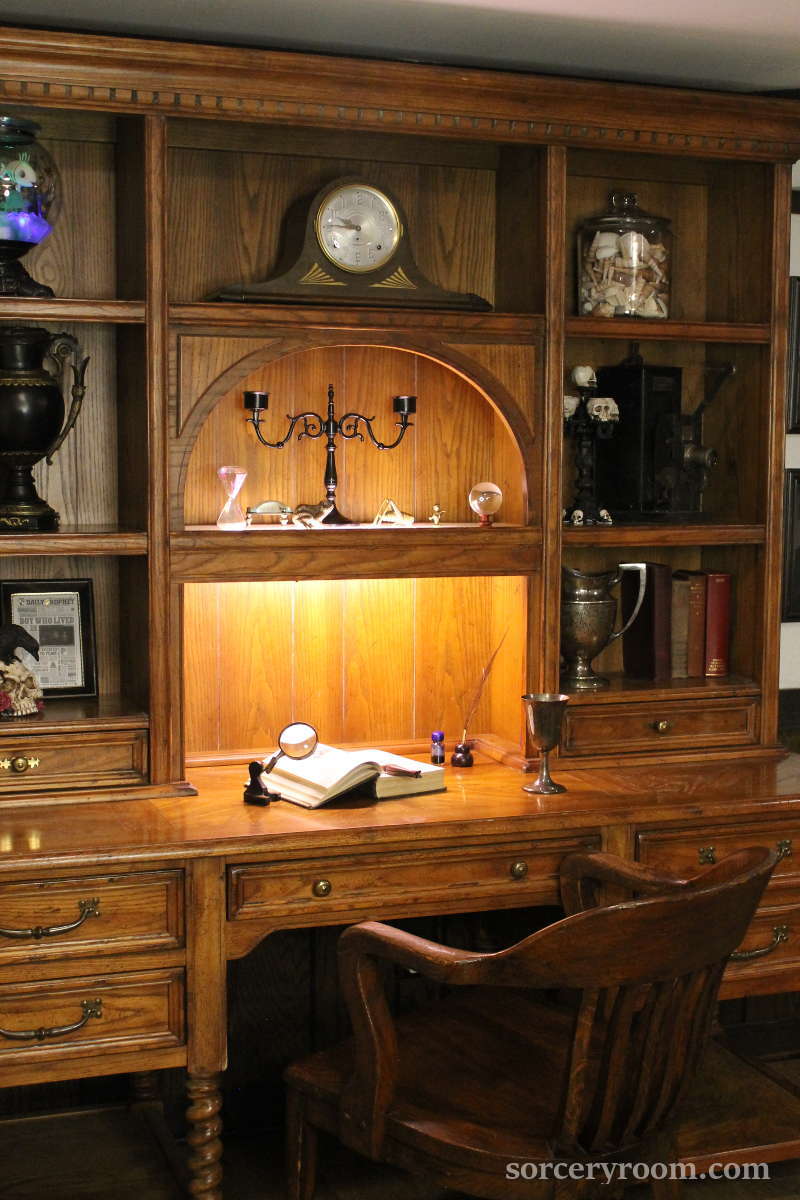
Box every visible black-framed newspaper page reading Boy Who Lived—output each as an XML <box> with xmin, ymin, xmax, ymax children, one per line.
<box><xmin>0</xmin><ymin>580</ymin><xmax>97</xmax><ymax>698</ymax></box>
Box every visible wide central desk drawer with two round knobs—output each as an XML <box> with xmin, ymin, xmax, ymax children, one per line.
<box><xmin>228</xmin><ymin>835</ymin><xmax>600</xmax><ymax>925</ymax></box>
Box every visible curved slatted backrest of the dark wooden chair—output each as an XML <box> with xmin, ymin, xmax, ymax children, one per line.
<box><xmin>482</xmin><ymin>848</ymin><xmax>776</xmax><ymax>1154</ymax></box>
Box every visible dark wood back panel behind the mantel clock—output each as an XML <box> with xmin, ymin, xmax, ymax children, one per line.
<box><xmin>169</xmin><ymin>146</ymin><xmax>494</xmax><ymax>302</ymax></box>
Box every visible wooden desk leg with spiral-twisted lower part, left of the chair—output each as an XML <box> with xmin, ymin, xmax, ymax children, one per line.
<box><xmin>186</xmin><ymin>858</ymin><xmax>228</xmax><ymax>1200</ymax></box>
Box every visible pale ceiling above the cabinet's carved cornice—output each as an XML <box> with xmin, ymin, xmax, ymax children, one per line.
<box><xmin>1</xmin><ymin>0</ymin><xmax>800</xmax><ymax>91</ymax></box>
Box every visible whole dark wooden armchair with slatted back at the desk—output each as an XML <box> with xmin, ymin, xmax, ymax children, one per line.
<box><xmin>285</xmin><ymin>848</ymin><xmax>776</xmax><ymax>1200</ymax></box>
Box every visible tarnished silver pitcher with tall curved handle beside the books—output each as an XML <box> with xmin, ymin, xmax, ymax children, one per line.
<box><xmin>561</xmin><ymin>563</ymin><xmax>648</xmax><ymax>691</ymax></box>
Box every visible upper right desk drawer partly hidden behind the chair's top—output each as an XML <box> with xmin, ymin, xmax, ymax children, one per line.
<box><xmin>636</xmin><ymin>820</ymin><xmax>800</xmax><ymax>886</ymax></box>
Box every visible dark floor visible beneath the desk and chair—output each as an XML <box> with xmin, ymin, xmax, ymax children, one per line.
<box><xmin>0</xmin><ymin>1109</ymin><xmax>800</xmax><ymax>1200</ymax></box>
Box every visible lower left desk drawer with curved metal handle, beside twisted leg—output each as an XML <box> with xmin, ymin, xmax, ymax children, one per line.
<box><xmin>0</xmin><ymin>970</ymin><xmax>185</xmax><ymax>1064</ymax></box>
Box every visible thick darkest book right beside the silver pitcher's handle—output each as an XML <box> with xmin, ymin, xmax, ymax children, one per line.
<box><xmin>621</xmin><ymin>563</ymin><xmax>672</xmax><ymax>679</ymax></box>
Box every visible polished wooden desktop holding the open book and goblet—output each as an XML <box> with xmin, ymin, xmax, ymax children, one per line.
<box><xmin>0</xmin><ymin>755</ymin><xmax>800</xmax><ymax>872</ymax></box>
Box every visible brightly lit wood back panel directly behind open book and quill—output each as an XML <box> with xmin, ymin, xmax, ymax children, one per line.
<box><xmin>184</xmin><ymin>576</ymin><xmax>527</xmax><ymax>756</ymax></box>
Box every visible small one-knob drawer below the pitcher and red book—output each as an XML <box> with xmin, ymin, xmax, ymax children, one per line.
<box><xmin>561</xmin><ymin>697</ymin><xmax>758</xmax><ymax>756</ymax></box>
